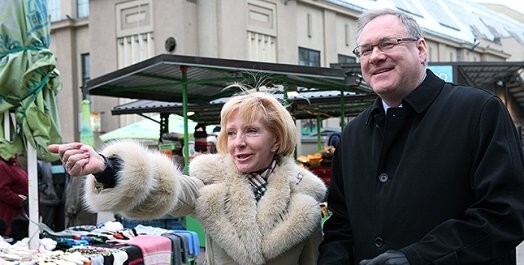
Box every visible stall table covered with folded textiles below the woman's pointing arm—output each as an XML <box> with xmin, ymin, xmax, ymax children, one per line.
<box><xmin>0</xmin><ymin>219</ymin><xmax>200</xmax><ymax>265</ymax></box>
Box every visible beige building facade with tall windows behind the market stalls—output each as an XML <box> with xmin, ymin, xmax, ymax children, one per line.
<box><xmin>47</xmin><ymin>0</ymin><xmax>524</xmax><ymax>142</ymax></box>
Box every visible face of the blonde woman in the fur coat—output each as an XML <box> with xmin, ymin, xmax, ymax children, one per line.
<box><xmin>225</xmin><ymin>110</ymin><xmax>278</xmax><ymax>173</ymax></box>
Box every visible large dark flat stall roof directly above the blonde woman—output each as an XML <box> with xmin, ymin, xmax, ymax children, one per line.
<box><xmin>87</xmin><ymin>54</ymin><xmax>370</xmax><ymax>104</ymax></box>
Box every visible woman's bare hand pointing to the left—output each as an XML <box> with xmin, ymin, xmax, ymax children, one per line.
<box><xmin>47</xmin><ymin>143</ymin><xmax>106</xmax><ymax>176</ymax></box>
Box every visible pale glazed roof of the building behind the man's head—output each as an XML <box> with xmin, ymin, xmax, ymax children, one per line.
<box><xmin>325</xmin><ymin>0</ymin><xmax>524</xmax><ymax>44</ymax></box>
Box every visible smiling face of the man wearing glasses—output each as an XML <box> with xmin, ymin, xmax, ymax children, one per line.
<box><xmin>358</xmin><ymin>15</ymin><xmax>426</xmax><ymax>107</ymax></box>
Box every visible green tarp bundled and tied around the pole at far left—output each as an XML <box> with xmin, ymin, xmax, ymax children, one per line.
<box><xmin>0</xmin><ymin>0</ymin><xmax>62</xmax><ymax>161</ymax></box>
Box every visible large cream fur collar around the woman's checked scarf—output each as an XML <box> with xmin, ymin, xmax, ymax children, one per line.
<box><xmin>190</xmin><ymin>155</ymin><xmax>326</xmax><ymax>264</ymax></box>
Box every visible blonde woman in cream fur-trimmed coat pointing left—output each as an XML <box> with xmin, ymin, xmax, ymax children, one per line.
<box><xmin>49</xmin><ymin>89</ymin><xmax>326</xmax><ymax>265</ymax></box>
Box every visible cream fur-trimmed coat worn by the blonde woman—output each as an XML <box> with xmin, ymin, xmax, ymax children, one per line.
<box><xmin>85</xmin><ymin>142</ymin><xmax>326</xmax><ymax>265</ymax></box>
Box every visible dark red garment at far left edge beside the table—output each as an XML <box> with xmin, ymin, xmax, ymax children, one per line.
<box><xmin>0</xmin><ymin>158</ymin><xmax>29</xmax><ymax>235</ymax></box>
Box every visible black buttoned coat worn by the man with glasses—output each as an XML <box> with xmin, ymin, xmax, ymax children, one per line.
<box><xmin>319</xmin><ymin>70</ymin><xmax>524</xmax><ymax>265</ymax></box>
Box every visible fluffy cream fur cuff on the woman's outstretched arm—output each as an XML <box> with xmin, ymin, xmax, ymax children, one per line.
<box><xmin>84</xmin><ymin>141</ymin><xmax>182</xmax><ymax>219</ymax></box>
